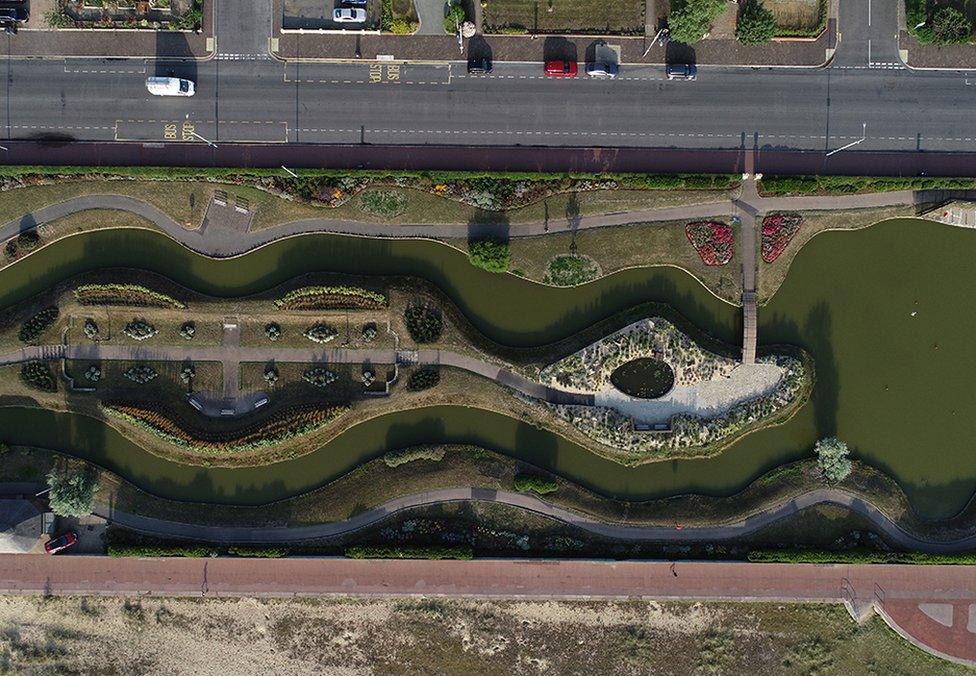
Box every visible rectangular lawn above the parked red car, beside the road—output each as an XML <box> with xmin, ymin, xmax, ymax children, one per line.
<box><xmin>484</xmin><ymin>0</ymin><xmax>644</xmax><ymax>35</ymax></box>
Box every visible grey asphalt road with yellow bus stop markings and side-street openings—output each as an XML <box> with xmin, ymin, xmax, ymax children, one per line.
<box><xmin>0</xmin><ymin>0</ymin><xmax>976</xmax><ymax>152</ymax></box>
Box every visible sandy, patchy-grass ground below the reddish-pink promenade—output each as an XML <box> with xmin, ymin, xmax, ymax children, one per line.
<box><xmin>0</xmin><ymin>597</ymin><xmax>962</xmax><ymax>674</ymax></box>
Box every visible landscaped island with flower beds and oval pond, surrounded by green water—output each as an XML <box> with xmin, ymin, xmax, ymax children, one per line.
<box><xmin>0</xmin><ymin>269</ymin><xmax>813</xmax><ymax>466</ymax></box>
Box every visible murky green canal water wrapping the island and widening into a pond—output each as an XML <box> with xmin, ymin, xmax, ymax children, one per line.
<box><xmin>0</xmin><ymin>220</ymin><xmax>976</xmax><ymax>518</ymax></box>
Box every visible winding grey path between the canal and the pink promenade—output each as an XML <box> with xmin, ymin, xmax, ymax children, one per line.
<box><xmin>95</xmin><ymin>487</ymin><xmax>976</xmax><ymax>554</ymax></box>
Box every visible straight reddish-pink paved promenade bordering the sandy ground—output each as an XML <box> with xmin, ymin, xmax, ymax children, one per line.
<box><xmin>0</xmin><ymin>555</ymin><xmax>976</xmax><ymax>665</ymax></box>
